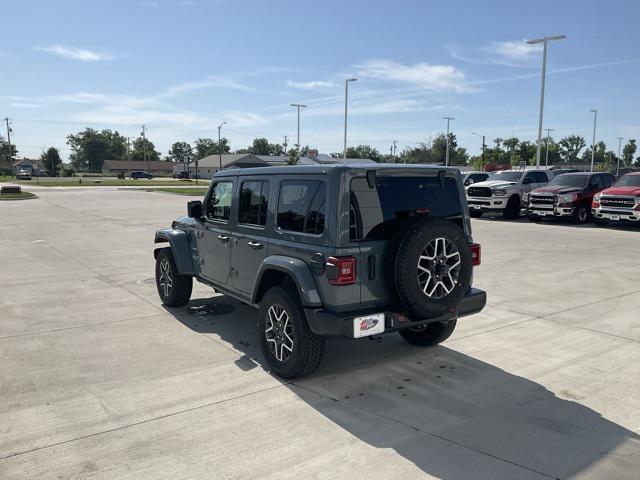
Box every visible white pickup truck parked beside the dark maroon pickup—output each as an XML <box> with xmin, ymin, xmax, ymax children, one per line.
<box><xmin>466</xmin><ymin>170</ymin><xmax>553</xmax><ymax>219</ymax></box>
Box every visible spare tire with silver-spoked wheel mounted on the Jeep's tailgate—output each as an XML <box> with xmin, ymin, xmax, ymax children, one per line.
<box><xmin>386</xmin><ymin>217</ymin><xmax>473</xmax><ymax>319</ymax></box>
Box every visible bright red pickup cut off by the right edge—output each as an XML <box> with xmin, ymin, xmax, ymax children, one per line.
<box><xmin>591</xmin><ymin>172</ymin><xmax>640</xmax><ymax>226</ymax></box>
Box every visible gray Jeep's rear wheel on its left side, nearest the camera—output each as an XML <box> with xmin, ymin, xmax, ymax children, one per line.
<box><xmin>258</xmin><ymin>287</ymin><xmax>325</xmax><ymax>379</ymax></box>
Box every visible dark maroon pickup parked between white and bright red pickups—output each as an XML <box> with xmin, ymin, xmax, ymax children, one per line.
<box><xmin>527</xmin><ymin>172</ymin><xmax>615</xmax><ymax>223</ymax></box>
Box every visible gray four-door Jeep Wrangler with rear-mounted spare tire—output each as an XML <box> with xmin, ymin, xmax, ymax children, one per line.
<box><xmin>154</xmin><ymin>164</ymin><xmax>486</xmax><ymax>378</ymax></box>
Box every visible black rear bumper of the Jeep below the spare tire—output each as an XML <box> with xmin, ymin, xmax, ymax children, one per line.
<box><xmin>305</xmin><ymin>288</ymin><xmax>487</xmax><ymax>338</ymax></box>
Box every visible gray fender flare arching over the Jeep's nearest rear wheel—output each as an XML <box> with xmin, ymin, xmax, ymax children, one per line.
<box><xmin>251</xmin><ymin>255</ymin><xmax>322</xmax><ymax>307</ymax></box>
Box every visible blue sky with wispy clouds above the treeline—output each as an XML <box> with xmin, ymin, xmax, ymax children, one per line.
<box><xmin>0</xmin><ymin>0</ymin><xmax>640</xmax><ymax>161</ymax></box>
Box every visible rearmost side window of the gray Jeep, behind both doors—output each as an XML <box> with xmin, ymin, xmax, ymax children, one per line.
<box><xmin>277</xmin><ymin>180</ymin><xmax>325</xmax><ymax>234</ymax></box>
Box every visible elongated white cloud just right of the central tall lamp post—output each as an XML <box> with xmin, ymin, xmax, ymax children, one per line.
<box><xmin>356</xmin><ymin>60</ymin><xmax>469</xmax><ymax>93</ymax></box>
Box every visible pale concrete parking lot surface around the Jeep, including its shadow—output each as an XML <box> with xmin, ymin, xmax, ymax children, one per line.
<box><xmin>0</xmin><ymin>187</ymin><xmax>640</xmax><ymax>479</ymax></box>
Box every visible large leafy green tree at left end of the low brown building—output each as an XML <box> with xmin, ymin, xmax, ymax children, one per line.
<box><xmin>67</xmin><ymin>128</ymin><xmax>126</xmax><ymax>172</ymax></box>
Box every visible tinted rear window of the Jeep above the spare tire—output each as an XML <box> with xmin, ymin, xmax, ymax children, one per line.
<box><xmin>349</xmin><ymin>176</ymin><xmax>462</xmax><ymax>240</ymax></box>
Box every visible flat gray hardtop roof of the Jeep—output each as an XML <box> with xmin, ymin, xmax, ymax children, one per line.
<box><xmin>214</xmin><ymin>163</ymin><xmax>459</xmax><ymax>178</ymax></box>
